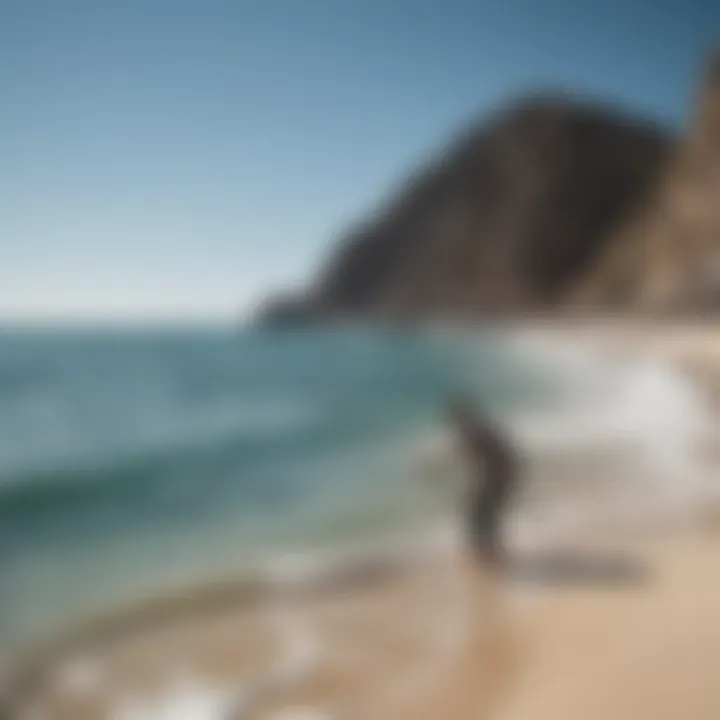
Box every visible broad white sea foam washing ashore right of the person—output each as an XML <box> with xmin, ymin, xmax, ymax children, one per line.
<box><xmin>422</xmin><ymin>333</ymin><xmax>720</xmax><ymax>545</ymax></box>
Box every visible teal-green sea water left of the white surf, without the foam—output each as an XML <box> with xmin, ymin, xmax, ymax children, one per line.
<box><xmin>0</xmin><ymin>330</ymin><xmax>556</xmax><ymax>648</ymax></box>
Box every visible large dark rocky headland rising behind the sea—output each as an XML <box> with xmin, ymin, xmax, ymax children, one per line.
<box><xmin>266</xmin><ymin>95</ymin><xmax>672</xmax><ymax>322</ymax></box>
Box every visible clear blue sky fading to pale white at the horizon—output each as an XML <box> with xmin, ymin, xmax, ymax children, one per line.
<box><xmin>0</xmin><ymin>0</ymin><xmax>720</xmax><ymax>322</ymax></box>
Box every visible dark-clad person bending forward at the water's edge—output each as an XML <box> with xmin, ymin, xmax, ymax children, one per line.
<box><xmin>447</xmin><ymin>399</ymin><xmax>518</xmax><ymax>565</ymax></box>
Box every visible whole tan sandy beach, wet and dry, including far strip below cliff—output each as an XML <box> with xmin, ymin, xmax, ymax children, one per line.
<box><xmin>8</xmin><ymin>328</ymin><xmax>720</xmax><ymax>720</ymax></box>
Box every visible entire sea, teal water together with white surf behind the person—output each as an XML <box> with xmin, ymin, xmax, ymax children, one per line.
<box><xmin>0</xmin><ymin>328</ymin><xmax>709</xmax><ymax>655</ymax></box>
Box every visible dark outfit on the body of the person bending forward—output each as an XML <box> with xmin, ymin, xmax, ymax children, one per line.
<box><xmin>461</xmin><ymin>422</ymin><xmax>517</xmax><ymax>560</ymax></box>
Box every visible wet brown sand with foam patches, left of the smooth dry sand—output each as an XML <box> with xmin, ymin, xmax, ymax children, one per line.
<box><xmin>8</xmin><ymin>552</ymin><xmax>507</xmax><ymax>720</ymax></box>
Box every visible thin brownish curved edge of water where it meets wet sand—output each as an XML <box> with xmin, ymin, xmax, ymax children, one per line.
<box><xmin>0</xmin><ymin>523</ymin><xmax>447</xmax><ymax>717</ymax></box>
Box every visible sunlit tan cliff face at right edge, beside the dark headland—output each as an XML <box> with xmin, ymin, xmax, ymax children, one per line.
<box><xmin>577</xmin><ymin>54</ymin><xmax>720</xmax><ymax>312</ymax></box>
